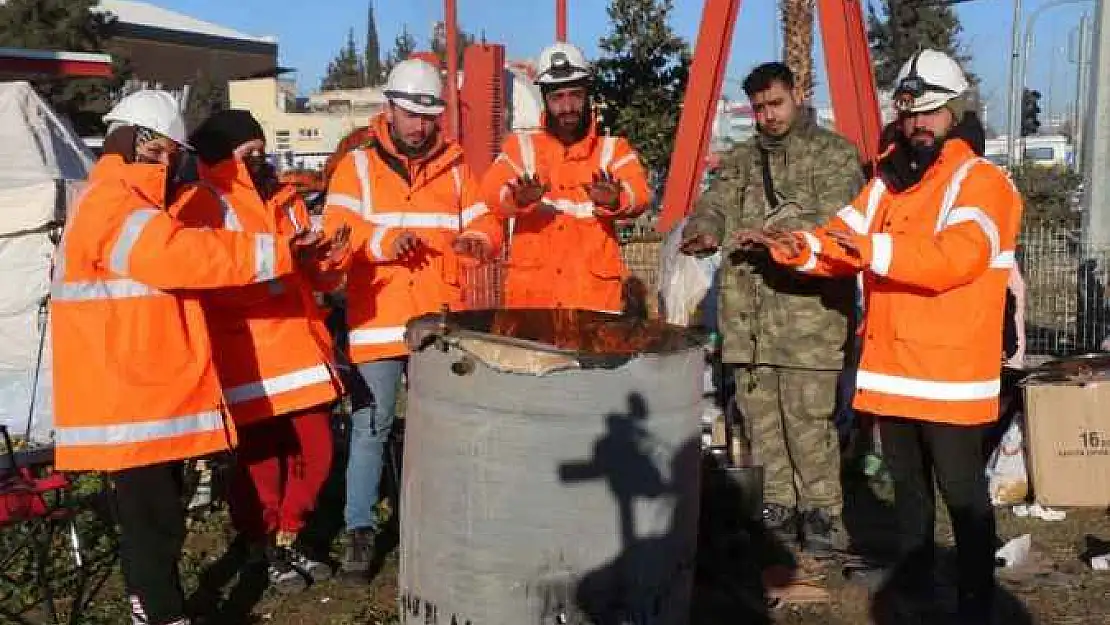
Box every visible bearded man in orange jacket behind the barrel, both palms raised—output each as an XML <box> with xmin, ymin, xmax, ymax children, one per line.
<box><xmin>482</xmin><ymin>43</ymin><xmax>650</xmax><ymax>312</ymax></box>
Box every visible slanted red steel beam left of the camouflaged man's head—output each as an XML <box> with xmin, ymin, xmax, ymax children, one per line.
<box><xmin>655</xmin><ymin>0</ymin><xmax>741</xmax><ymax>232</ymax></box>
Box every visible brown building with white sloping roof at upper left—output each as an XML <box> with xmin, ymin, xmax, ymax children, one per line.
<box><xmin>99</xmin><ymin>0</ymin><xmax>278</xmax><ymax>92</ymax></box>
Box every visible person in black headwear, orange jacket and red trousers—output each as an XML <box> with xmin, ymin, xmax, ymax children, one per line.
<box><xmin>176</xmin><ymin>110</ymin><xmax>339</xmax><ymax>592</ymax></box>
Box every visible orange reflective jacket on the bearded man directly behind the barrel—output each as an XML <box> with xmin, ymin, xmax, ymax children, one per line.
<box><xmin>482</xmin><ymin>120</ymin><xmax>650</xmax><ymax>312</ymax></box>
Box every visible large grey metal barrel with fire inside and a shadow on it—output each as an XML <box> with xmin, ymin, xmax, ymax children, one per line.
<box><xmin>400</xmin><ymin>310</ymin><xmax>704</xmax><ymax>625</ymax></box>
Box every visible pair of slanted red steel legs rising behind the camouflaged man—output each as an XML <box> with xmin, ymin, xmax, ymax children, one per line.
<box><xmin>655</xmin><ymin>0</ymin><xmax>881</xmax><ymax>232</ymax></box>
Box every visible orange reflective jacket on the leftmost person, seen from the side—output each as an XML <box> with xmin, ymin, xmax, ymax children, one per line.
<box><xmin>50</xmin><ymin>154</ymin><xmax>293</xmax><ymax>471</ymax></box>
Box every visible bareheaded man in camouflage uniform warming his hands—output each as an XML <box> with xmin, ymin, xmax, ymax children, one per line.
<box><xmin>683</xmin><ymin>63</ymin><xmax>864</xmax><ymax>555</ymax></box>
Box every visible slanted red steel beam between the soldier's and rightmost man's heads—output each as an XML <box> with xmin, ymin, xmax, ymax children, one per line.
<box><xmin>817</xmin><ymin>0</ymin><xmax>882</xmax><ymax>163</ymax></box>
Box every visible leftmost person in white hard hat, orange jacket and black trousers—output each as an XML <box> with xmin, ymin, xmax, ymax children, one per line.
<box><xmin>50</xmin><ymin>91</ymin><xmax>322</xmax><ymax>625</ymax></box>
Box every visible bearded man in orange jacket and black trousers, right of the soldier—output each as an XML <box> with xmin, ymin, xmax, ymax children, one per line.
<box><xmin>738</xmin><ymin>50</ymin><xmax>1021</xmax><ymax>623</ymax></box>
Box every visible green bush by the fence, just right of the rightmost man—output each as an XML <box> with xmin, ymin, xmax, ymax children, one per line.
<box><xmin>1013</xmin><ymin>164</ymin><xmax>1083</xmax><ymax>230</ymax></box>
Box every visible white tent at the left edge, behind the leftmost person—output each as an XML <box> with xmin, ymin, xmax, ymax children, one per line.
<box><xmin>0</xmin><ymin>82</ymin><xmax>92</xmax><ymax>443</ymax></box>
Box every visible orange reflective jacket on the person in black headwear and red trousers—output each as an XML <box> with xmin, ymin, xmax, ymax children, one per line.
<box><xmin>170</xmin><ymin>159</ymin><xmax>337</xmax><ymax>425</ymax></box>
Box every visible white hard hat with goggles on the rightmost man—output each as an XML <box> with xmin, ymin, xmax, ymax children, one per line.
<box><xmin>894</xmin><ymin>50</ymin><xmax>970</xmax><ymax>113</ymax></box>
